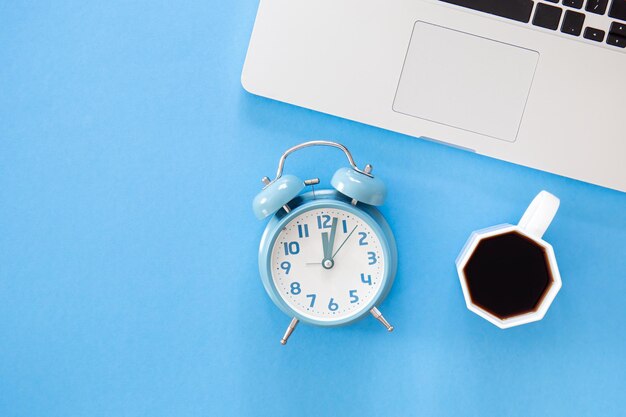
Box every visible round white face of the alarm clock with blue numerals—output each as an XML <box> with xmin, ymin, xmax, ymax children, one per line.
<box><xmin>270</xmin><ymin>208</ymin><xmax>387</xmax><ymax>322</ymax></box>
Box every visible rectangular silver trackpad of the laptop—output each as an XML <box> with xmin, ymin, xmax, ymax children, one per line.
<box><xmin>393</xmin><ymin>22</ymin><xmax>539</xmax><ymax>142</ymax></box>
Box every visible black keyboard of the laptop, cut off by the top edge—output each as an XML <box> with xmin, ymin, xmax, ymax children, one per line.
<box><xmin>440</xmin><ymin>0</ymin><xmax>626</xmax><ymax>49</ymax></box>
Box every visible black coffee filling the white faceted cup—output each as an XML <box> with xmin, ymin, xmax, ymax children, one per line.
<box><xmin>463</xmin><ymin>232</ymin><xmax>552</xmax><ymax>319</ymax></box>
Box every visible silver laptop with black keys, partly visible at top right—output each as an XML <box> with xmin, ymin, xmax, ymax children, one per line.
<box><xmin>242</xmin><ymin>0</ymin><xmax>626</xmax><ymax>191</ymax></box>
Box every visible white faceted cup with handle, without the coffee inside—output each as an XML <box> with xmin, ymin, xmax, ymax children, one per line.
<box><xmin>456</xmin><ymin>191</ymin><xmax>562</xmax><ymax>329</ymax></box>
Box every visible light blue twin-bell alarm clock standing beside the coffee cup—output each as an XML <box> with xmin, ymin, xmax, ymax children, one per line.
<box><xmin>252</xmin><ymin>141</ymin><xmax>398</xmax><ymax>345</ymax></box>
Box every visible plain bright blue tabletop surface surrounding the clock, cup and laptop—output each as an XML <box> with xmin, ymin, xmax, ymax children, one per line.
<box><xmin>0</xmin><ymin>0</ymin><xmax>626</xmax><ymax>417</ymax></box>
